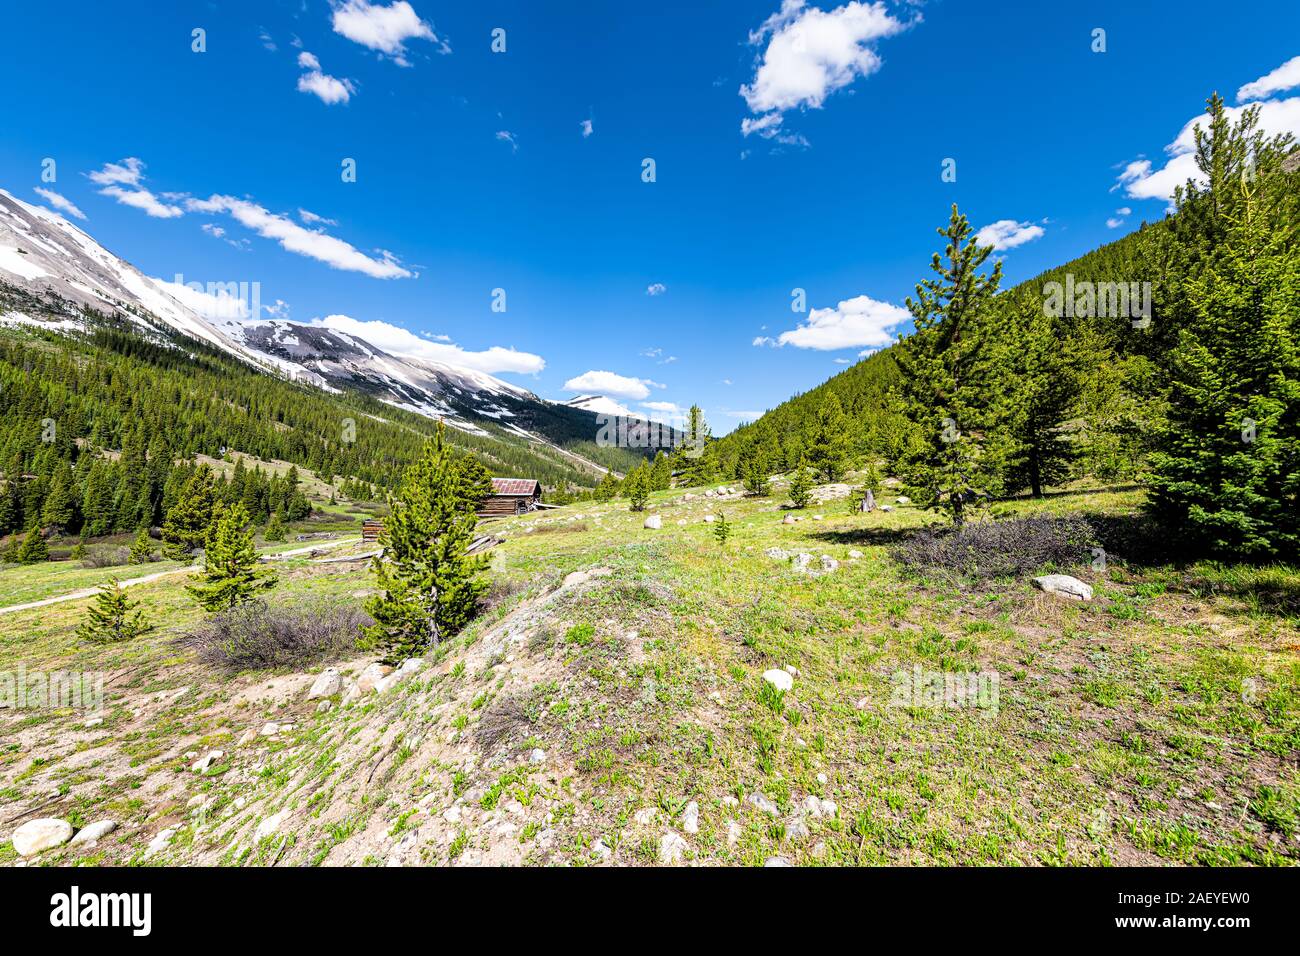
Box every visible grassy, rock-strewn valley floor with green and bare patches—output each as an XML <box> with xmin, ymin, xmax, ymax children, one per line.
<box><xmin>0</xmin><ymin>488</ymin><xmax>1300</xmax><ymax>866</ymax></box>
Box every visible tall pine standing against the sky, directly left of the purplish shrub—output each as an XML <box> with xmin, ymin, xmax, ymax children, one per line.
<box><xmin>897</xmin><ymin>204</ymin><xmax>1002</xmax><ymax>525</ymax></box>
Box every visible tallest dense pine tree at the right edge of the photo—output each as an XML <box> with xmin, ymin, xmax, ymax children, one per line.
<box><xmin>1151</xmin><ymin>96</ymin><xmax>1300</xmax><ymax>561</ymax></box>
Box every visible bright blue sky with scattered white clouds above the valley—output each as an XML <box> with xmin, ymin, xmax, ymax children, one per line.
<box><xmin>0</xmin><ymin>0</ymin><xmax>1300</xmax><ymax>432</ymax></box>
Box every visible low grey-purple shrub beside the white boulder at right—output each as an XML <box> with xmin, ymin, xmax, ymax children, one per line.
<box><xmin>891</xmin><ymin>515</ymin><xmax>1097</xmax><ymax>580</ymax></box>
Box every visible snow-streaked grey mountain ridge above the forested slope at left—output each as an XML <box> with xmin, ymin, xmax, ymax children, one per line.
<box><xmin>0</xmin><ymin>190</ymin><xmax>595</xmax><ymax>441</ymax></box>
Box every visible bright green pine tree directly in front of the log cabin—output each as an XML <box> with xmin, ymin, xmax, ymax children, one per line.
<box><xmin>359</xmin><ymin>423</ymin><xmax>488</xmax><ymax>661</ymax></box>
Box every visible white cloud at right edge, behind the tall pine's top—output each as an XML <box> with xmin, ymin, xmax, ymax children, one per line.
<box><xmin>1112</xmin><ymin>74</ymin><xmax>1300</xmax><ymax>202</ymax></box>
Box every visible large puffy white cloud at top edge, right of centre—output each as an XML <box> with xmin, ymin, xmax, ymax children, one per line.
<box><xmin>740</xmin><ymin>0</ymin><xmax>920</xmax><ymax>144</ymax></box>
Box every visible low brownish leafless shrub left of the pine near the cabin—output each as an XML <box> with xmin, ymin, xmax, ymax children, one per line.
<box><xmin>179</xmin><ymin>601</ymin><xmax>374</xmax><ymax>671</ymax></box>
